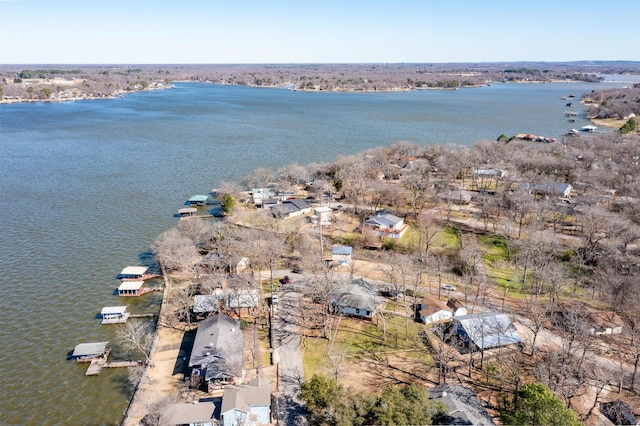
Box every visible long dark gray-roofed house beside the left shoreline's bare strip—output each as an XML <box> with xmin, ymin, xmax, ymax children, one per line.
<box><xmin>189</xmin><ymin>314</ymin><xmax>244</xmax><ymax>391</ymax></box>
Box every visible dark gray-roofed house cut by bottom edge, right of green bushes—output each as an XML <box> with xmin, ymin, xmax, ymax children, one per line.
<box><xmin>429</xmin><ymin>383</ymin><xmax>495</xmax><ymax>426</ymax></box>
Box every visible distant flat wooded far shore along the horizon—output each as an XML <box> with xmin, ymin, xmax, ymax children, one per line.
<box><xmin>0</xmin><ymin>61</ymin><xmax>640</xmax><ymax>103</ymax></box>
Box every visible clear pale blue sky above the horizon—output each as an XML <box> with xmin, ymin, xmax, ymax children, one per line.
<box><xmin>0</xmin><ymin>0</ymin><xmax>640</xmax><ymax>64</ymax></box>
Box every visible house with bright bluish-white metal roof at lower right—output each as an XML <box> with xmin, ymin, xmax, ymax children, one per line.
<box><xmin>453</xmin><ymin>312</ymin><xmax>522</xmax><ymax>351</ymax></box>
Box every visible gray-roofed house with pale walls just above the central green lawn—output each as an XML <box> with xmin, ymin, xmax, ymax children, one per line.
<box><xmin>332</xmin><ymin>278</ymin><xmax>384</xmax><ymax>320</ymax></box>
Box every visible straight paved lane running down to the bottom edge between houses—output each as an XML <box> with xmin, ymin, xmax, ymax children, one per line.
<box><xmin>272</xmin><ymin>285</ymin><xmax>308</xmax><ymax>426</ymax></box>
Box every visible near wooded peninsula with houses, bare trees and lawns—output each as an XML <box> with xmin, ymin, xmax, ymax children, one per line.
<box><xmin>116</xmin><ymin>114</ymin><xmax>640</xmax><ymax>425</ymax></box>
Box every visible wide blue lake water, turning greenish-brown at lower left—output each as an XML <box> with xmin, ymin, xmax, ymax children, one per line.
<box><xmin>0</xmin><ymin>78</ymin><xmax>623</xmax><ymax>425</ymax></box>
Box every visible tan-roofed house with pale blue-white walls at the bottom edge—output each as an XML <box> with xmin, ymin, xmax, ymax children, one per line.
<box><xmin>220</xmin><ymin>378</ymin><xmax>271</xmax><ymax>426</ymax></box>
